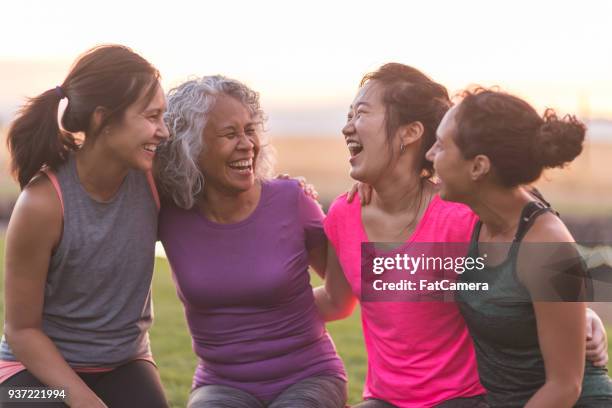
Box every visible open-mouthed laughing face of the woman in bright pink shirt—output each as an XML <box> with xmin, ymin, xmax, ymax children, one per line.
<box><xmin>342</xmin><ymin>80</ymin><xmax>391</xmax><ymax>184</ymax></box>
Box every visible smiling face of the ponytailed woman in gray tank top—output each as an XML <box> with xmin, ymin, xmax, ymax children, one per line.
<box><xmin>99</xmin><ymin>84</ymin><xmax>169</xmax><ymax>171</ymax></box>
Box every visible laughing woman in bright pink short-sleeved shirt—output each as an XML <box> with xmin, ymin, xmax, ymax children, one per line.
<box><xmin>315</xmin><ymin>63</ymin><xmax>605</xmax><ymax>408</ymax></box>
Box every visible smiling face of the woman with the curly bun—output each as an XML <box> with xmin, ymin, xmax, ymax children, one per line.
<box><xmin>426</xmin><ymin>105</ymin><xmax>475</xmax><ymax>202</ymax></box>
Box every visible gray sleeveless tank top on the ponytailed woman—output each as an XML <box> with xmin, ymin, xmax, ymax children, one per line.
<box><xmin>0</xmin><ymin>156</ymin><xmax>158</xmax><ymax>367</ymax></box>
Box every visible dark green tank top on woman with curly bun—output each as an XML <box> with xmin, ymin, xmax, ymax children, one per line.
<box><xmin>456</xmin><ymin>197</ymin><xmax>612</xmax><ymax>408</ymax></box>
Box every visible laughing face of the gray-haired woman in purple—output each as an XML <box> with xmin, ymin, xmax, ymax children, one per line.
<box><xmin>198</xmin><ymin>94</ymin><xmax>261</xmax><ymax>193</ymax></box>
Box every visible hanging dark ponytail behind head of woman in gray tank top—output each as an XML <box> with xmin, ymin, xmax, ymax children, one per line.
<box><xmin>7</xmin><ymin>89</ymin><xmax>76</xmax><ymax>189</ymax></box>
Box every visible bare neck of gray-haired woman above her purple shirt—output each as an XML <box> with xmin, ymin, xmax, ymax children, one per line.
<box><xmin>196</xmin><ymin>181</ymin><xmax>262</xmax><ymax>224</ymax></box>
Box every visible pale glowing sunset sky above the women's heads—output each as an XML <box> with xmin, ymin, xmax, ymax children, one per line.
<box><xmin>0</xmin><ymin>0</ymin><xmax>612</xmax><ymax>134</ymax></box>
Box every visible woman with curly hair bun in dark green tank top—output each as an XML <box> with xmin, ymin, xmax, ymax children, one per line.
<box><xmin>427</xmin><ymin>89</ymin><xmax>612</xmax><ymax>407</ymax></box>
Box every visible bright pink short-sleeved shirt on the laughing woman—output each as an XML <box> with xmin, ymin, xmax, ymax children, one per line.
<box><xmin>325</xmin><ymin>195</ymin><xmax>485</xmax><ymax>408</ymax></box>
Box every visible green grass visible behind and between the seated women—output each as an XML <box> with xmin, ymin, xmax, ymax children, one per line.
<box><xmin>0</xmin><ymin>238</ymin><xmax>612</xmax><ymax>407</ymax></box>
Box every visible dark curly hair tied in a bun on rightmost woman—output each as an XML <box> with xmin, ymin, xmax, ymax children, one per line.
<box><xmin>455</xmin><ymin>88</ymin><xmax>586</xmax><ymax>187</ymax></box>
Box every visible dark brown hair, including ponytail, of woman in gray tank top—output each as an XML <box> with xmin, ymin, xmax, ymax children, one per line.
<box><xmin>7</xmin><ymin>45</ymin><xmax>159</xmax><ymax>189</ymax></box>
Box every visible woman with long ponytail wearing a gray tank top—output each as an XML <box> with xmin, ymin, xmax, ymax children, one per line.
<box><xmin>0</xmin><ymin>45</ymin><xmax>168</xmax><ymax>407</ymax></box>
